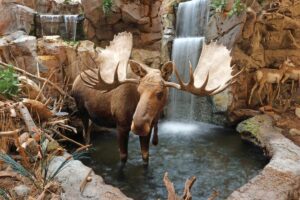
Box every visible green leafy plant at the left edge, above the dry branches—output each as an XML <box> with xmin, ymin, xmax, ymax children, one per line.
<box><xmin>0</xmin><ymin>66</ymin><xmax>19</xmax><ymax>97</ymax></box>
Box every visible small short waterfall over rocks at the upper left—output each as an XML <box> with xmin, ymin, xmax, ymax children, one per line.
<box><xmin>39</xmin><ymin>14</ymin><xmax>78</xmax><ymax>40</ymax></box>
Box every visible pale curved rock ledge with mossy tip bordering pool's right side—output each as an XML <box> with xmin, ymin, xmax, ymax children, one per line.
<box><xmin>228</xmin><ymin>115</ymin><xmax>300</xmax><ymax>200</ymax></box>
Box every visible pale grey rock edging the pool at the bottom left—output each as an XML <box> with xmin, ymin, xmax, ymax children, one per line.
<box><xmin>49</xmin><ymin>157</ymin><xmax>130</xmax><ymax>200</ymax></box>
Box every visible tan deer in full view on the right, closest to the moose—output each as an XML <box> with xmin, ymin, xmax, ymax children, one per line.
<box><xmin>248</xmin><ymin>59</ymin><xmax>294</xmax><ymax>105</ymax></box>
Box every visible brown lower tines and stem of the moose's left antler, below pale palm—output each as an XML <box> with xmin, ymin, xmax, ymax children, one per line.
<box><xmin>80</xmin><ymin>63</ymin><xmax>139</xmax><ymax>92</ymax></box>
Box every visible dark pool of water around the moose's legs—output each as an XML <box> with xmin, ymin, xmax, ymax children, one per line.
<box><xmin>87</xmin><ymin>121</ymin><xmax>268</xmax><ymax>200</ymax></box>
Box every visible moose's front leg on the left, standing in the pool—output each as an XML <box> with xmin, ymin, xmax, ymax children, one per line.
<box><xmin>117</xmin><ymin>126</ymin><xmax>130</xmax><ymax>165</ymax></box>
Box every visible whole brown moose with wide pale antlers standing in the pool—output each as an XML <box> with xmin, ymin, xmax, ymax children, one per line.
<box><xmin>72</xmin><ymin>32</ymin><xmax>234</xmax><ymax>165</ymax></box>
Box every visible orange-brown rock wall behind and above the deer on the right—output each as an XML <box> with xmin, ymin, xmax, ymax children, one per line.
<box><xmin>206</xmin><ymin>0</ymin><xmax>300</xmax><ymax>122</ymax></box>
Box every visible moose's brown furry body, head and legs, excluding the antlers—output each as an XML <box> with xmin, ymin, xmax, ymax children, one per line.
<box><xmin>72</xmin><ymin>62</ymin><xmax>173</xmax><ymax>163</ymax></box>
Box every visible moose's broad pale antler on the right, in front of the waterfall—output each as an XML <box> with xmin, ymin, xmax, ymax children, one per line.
<box><xmin>165</xmin><ymin>42</ymin><xmax>240</xmax><ymax>96</ymax></box>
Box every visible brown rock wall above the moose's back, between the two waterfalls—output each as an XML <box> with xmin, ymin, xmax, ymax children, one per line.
<box><xmin>82</xmin><ymin>0</ymin><xmax>162</xmax><ymax>51</ymax></box>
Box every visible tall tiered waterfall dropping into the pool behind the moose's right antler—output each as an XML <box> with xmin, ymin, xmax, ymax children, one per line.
<box><xmin>167</xmin><ymin>0</ymin><xmax>210</xmax><ymax>121</ymax></box>
